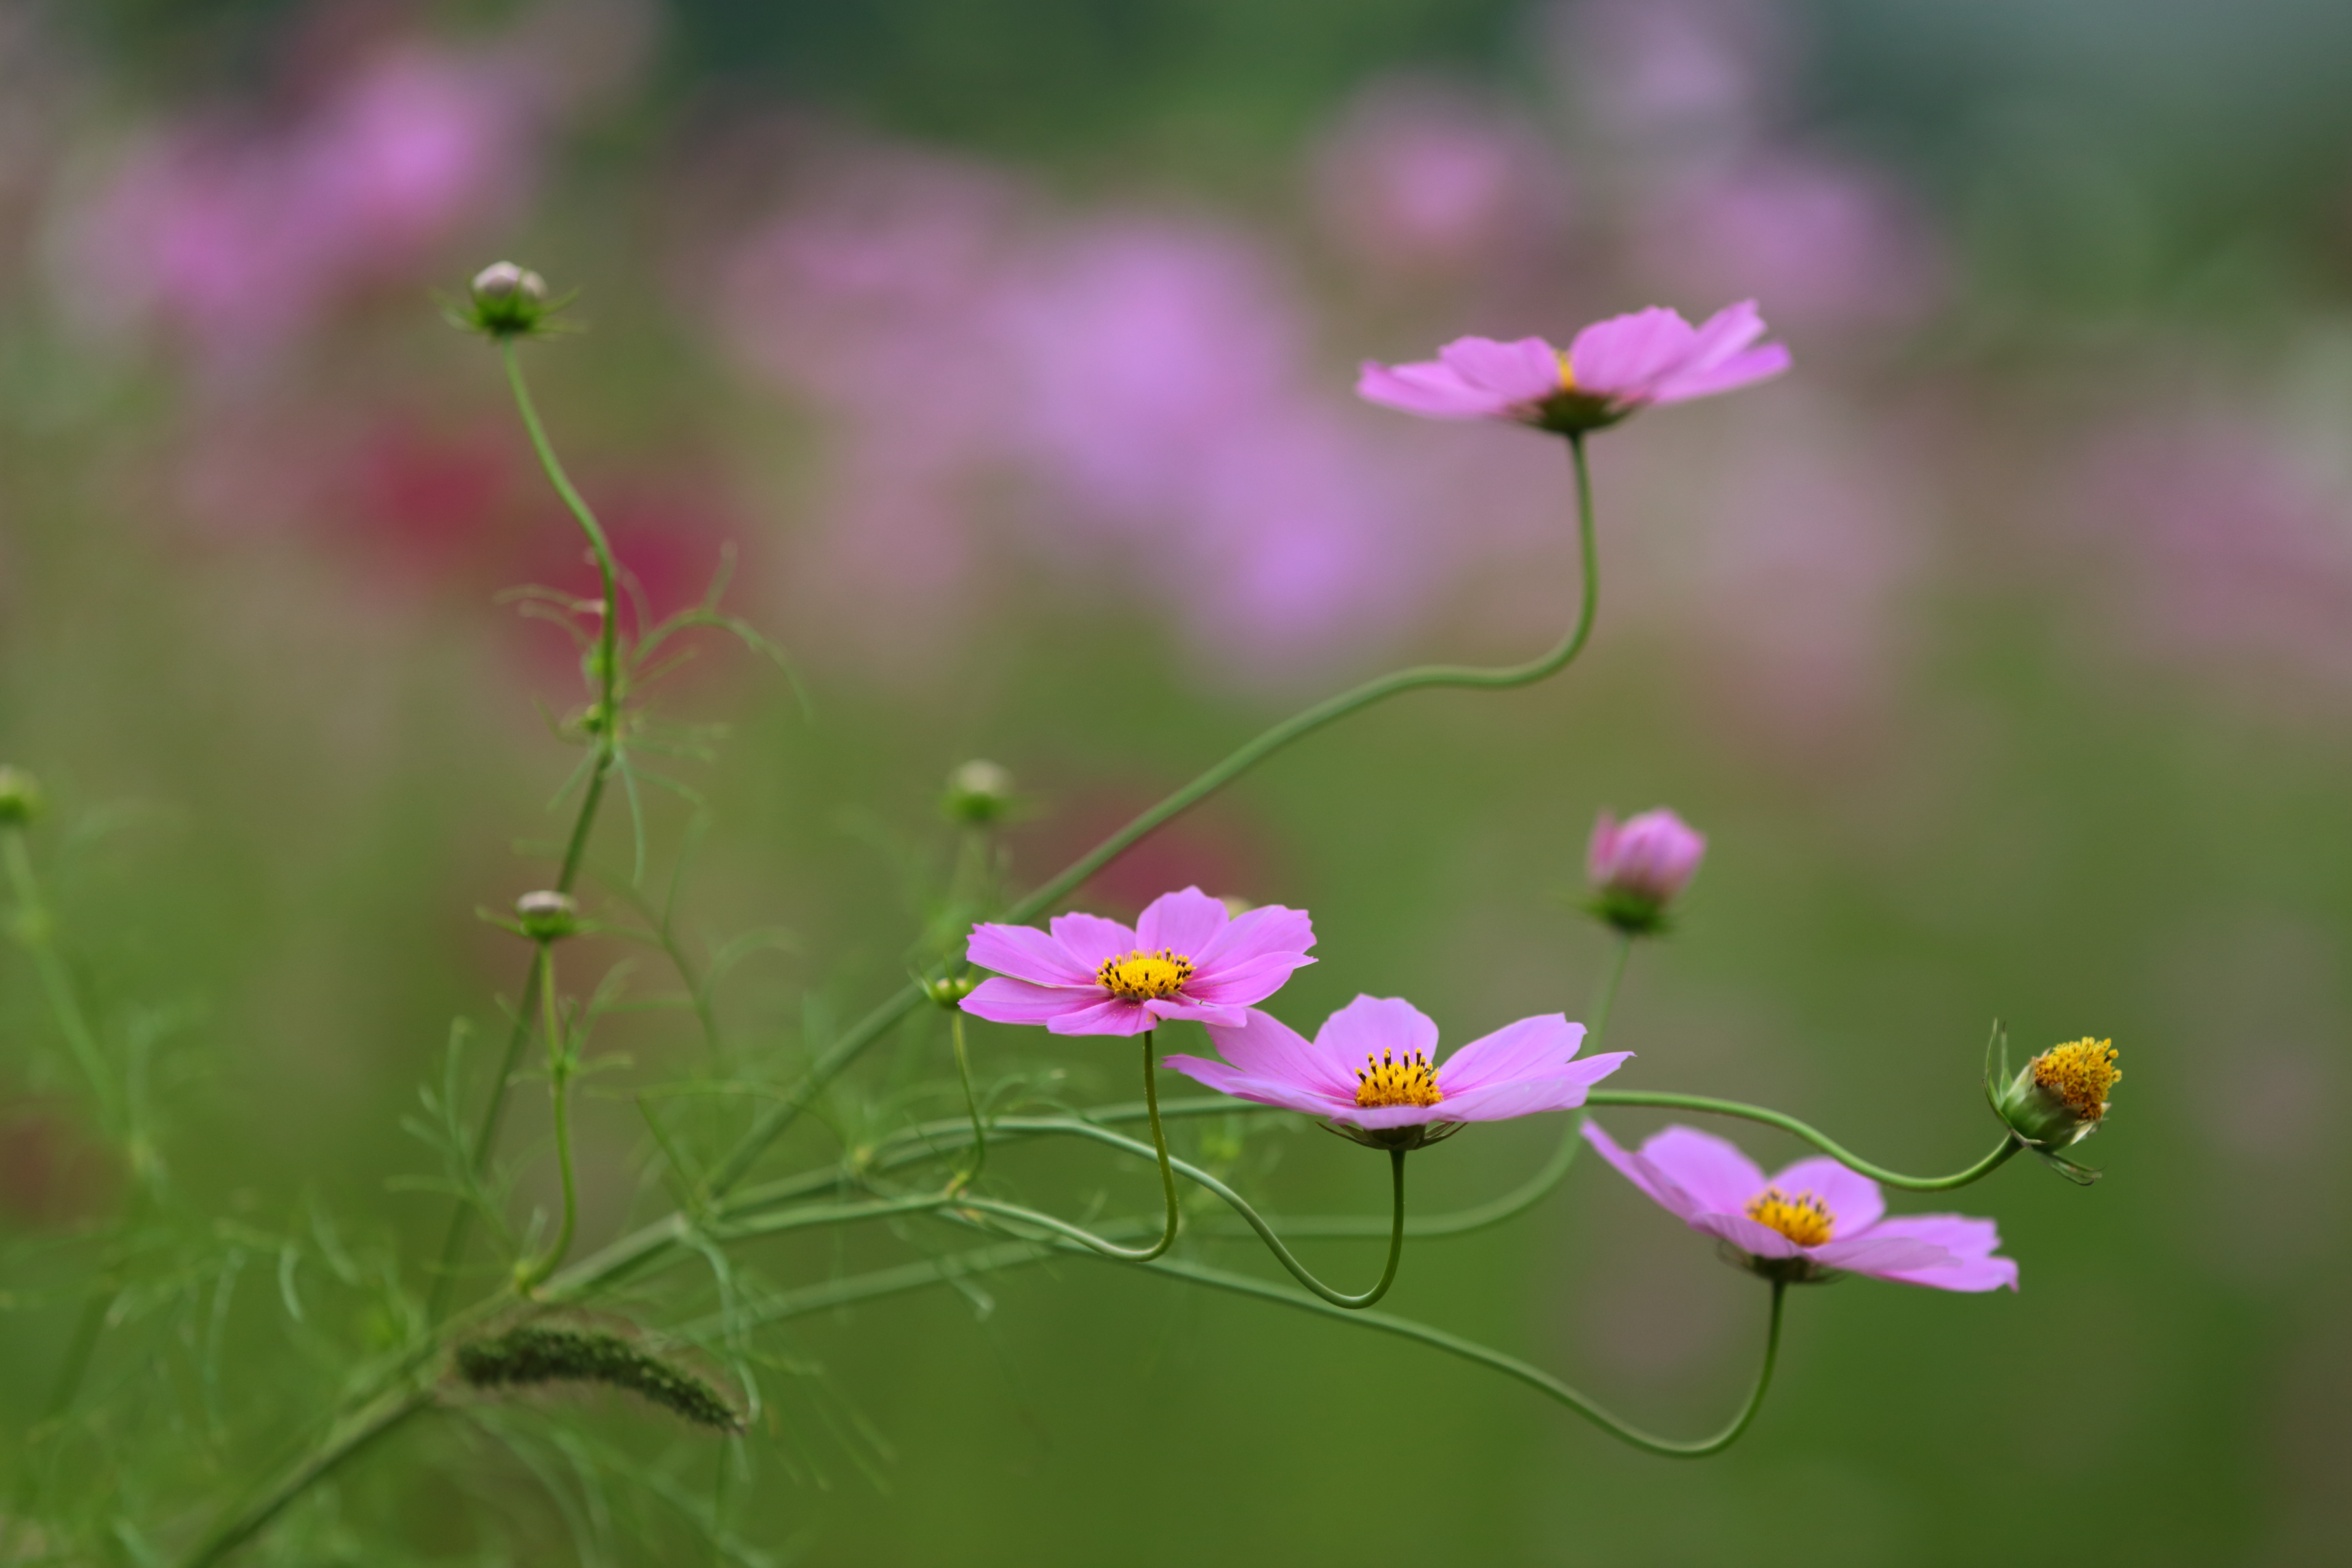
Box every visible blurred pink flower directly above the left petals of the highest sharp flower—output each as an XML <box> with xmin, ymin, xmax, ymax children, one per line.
<box><xmin>1315</xmin><ymin>83</ymin><xmax>1567</xmax><ymax>273</ymax></box>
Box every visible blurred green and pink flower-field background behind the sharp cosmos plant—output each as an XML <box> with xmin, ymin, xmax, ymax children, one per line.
<box><xmin>0</xmin><ymin>0</ymin><xmax>2352</xmax><ymax>1566</ymax></box>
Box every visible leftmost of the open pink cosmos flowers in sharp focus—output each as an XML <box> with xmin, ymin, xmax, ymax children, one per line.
<box><xmin>964</xmin><ymin>889</ymin><xmax>1315</xmax><ymax>1034</ymax></box>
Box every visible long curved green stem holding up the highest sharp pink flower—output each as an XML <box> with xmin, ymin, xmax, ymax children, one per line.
<box><xmin>710</xmin><ymin>435</ymin><xmax>1600</xmax><ymax>1192</ymax></box>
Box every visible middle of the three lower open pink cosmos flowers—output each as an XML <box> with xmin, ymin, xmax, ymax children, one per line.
<box><xmin>1162</xmin><ymin>997</ymin><xmax>1632</xmax><ymax>1150</ymax></box>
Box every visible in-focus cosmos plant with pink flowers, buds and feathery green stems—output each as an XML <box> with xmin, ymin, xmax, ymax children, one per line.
<box><xmin>0</xmin><ymin>276</ymin><xmax>2119</xmax><ymax>1568</ymax></box>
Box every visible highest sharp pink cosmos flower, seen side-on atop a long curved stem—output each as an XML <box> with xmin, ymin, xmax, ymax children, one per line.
<box><xmin>1355</xmin><ymin>298</ymin><xmax>1787</xmax><ymax>435</ymax></box>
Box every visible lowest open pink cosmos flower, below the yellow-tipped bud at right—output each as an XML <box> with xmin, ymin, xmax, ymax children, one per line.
<box><xmin>1585</xmin><ymin>1122</ymin><xmax>2018</xmax><ymax>1291</ymax></box>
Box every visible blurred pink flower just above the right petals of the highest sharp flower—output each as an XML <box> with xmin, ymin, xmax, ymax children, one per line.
<box><xmin>1635</xmin><ymin>153</ymin><xmax>1945</xmax><ymax>327</ymax></box>
